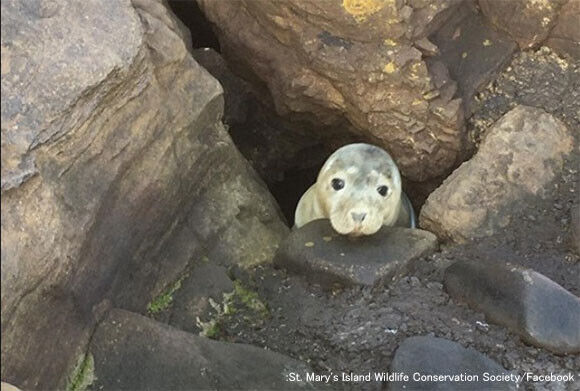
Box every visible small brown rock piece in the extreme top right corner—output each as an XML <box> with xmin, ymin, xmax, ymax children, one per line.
<box><xmin>546</xmin><ymin>0</ymin><xmax>580</xmax><ymax>60</ymax></box>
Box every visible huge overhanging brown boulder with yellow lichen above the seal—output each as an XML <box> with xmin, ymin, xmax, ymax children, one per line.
<box><xmin>198</xmin><ymin>0</ymin><xmax>464</xmax><ymax>181</ymax></box>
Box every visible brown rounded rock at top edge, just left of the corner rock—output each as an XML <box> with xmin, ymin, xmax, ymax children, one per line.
<box><xmin>479</xmin><ymin>0</ymin><xmax>566</xmax><ymax>49</ymax></box>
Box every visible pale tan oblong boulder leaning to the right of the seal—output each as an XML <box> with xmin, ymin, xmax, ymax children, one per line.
<box><xmin>419</xmin><ymin>106</ymin><xmax>573</xmax><ymax>242</ymax></box>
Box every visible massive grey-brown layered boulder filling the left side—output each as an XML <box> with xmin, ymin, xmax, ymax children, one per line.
<box><xmin>1</xmin><ymin>0</ymin><xmax>287</xmax><ymax>390</ymax></box>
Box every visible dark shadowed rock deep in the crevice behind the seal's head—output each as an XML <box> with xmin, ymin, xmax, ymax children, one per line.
<box><xmin>193</xmin><ymin>47</ymin><xmax>356</xmax><ymax>222</ymax></box>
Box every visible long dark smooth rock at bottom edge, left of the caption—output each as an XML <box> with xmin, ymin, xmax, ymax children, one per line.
<box><xmin>89</xmin><ymin>309</ymin><xmax>313</xmax><ymax>390</ymax></box>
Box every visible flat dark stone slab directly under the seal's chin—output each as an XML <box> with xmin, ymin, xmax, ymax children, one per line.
<box><xmin>274</xmin><ymin>220</ymin><xmax>437</xmax><ymax>287</ymax></box>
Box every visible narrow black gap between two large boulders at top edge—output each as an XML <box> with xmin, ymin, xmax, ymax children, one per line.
<box><xmin>168</xmin><ymin>0</ymin><xmax>220</xmax><ymax>52</ymax></box>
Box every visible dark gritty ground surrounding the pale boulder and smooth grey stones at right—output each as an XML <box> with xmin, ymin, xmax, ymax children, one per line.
<box><xmin>210</xmin><ymin>49</ymin><xmax>580</xmax><ymax>390</ymax></box>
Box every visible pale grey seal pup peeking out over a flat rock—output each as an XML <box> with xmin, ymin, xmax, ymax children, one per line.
<box><xmin>294</xmin><ymin>143</ymin><xmax>416</xmax><ymax>236</ymax></box>
